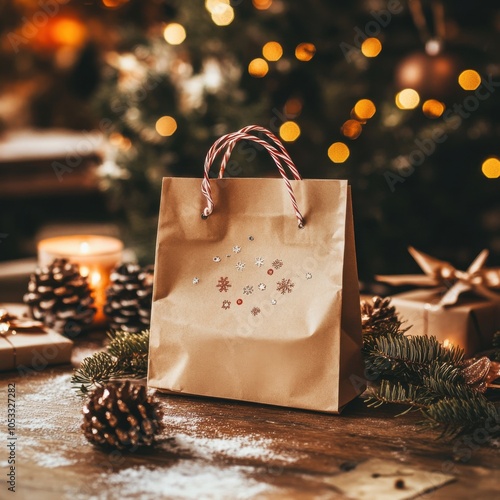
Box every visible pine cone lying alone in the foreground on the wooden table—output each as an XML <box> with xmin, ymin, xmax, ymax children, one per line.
<box><xmin>81</xmin><ymin>381</ymin><xmax>163</xmax><ymax>450</ymax></box>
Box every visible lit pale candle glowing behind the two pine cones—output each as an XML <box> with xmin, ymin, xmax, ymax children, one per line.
<box><xmin>38</xmin><ymin>235</ymin><xmax>123</xmax><ymax>322</ymax></box>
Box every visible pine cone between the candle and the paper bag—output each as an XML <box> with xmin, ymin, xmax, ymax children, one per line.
<box><xmin>104</xmin><ymin>264</ymin><xmax>153</xmax><ymax>333</ymax></box>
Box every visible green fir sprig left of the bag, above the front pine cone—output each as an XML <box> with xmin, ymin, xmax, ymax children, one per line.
<box><xmin>71</xmin><ymin>331</ymin><xmax>149</xmax><ymax>394</ymax></box>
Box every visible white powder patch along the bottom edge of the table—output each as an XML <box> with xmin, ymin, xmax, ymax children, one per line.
<box><xmin>101</xmin><ymin>460</ymin><xmax>274</xmax><ymax>500</ymax></box>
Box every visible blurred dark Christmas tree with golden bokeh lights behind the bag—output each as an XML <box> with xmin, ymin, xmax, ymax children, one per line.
<box><xmin>0</xmin><ymin>0</ymin><xmax>500</xmax><ymax>279</ymax></box>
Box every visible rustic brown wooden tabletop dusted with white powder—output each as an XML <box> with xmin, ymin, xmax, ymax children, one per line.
<box><xmin>0</xmin><ymin>337</ymin><xmax>500</xmax><ymax>500</ymax></box>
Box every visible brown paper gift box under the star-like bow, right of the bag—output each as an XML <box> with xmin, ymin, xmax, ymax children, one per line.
<box><xmin>392</xmin><ymin>289</ymin><xmax>500</xmax><ymax>356</ymax></box>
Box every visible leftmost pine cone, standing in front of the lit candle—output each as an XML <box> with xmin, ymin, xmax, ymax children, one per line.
<box><xmin>23</xmin><ymin>259</ymin><xmax>96</xmax><ymax>335</ymax></box>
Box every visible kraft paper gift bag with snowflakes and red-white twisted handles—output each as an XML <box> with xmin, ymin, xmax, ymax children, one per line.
<box><xmin>148</xmin><ymin>126</ymin><xmax>363</xmax><ymax>413</ymax></box>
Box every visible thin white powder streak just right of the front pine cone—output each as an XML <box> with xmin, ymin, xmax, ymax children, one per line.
<box><xmin>162</xmin><ymin>434</ymin><xmax>298</xmax><ymax>462</ymax></box>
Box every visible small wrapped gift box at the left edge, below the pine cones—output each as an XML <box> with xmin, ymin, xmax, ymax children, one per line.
<box><xmin>0</xmin><ymin>304</ymin><xmax>73</xmax><ymax>371</ymax></box>
